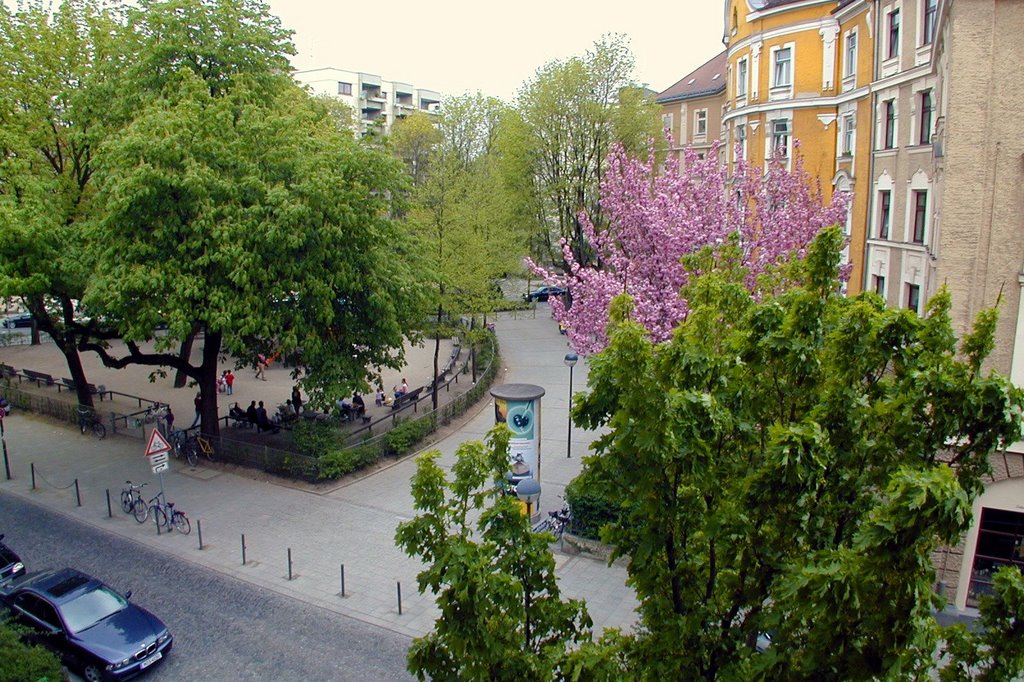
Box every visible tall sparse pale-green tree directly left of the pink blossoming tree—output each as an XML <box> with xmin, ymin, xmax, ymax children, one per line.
<box><xmin>511</xmin><ymin>35</ymin><xmax>660</xmax><ymax>272</ymax></box>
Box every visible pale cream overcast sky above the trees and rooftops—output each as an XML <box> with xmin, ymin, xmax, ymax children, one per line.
<box><xmin>266</xmin><ymin>0</ymin><xmax>725</xmax><ymax>101</ymax></box>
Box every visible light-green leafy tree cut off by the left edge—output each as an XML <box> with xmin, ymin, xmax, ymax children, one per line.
<box><xmin>0</xmin><ymin>0</ymin><xmax>125</xmax><ymax>406</ymax></box>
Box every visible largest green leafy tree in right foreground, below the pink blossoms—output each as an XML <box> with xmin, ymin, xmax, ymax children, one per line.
<box><xmin>573</xmin><ymin>228</ymin><xmax>1024</xmax><ymax>680</ymax></box>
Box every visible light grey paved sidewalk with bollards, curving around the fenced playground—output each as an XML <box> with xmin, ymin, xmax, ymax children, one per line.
<box><xmin>0</xmin><ymin>304</ymin><xmax>636</xmax><ymax>637</ymax></box>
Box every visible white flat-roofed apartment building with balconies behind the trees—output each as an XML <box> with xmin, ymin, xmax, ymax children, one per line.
<box><xmin>292</xmin><ymin>67</ymin><xmax>441</xmax><ymax>134</ymax></box>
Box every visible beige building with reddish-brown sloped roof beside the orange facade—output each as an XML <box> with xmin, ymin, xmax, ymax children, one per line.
<box><xmin>655</xmin><ymin>51</ymin><xmax>726</xmax><ymax>162</ymax></box>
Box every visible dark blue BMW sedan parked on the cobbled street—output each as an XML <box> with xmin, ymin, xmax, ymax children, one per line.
<box><xmin>0</xmin><ymin>568</ymin><xmax>174</xmax><ymax>682</ymax></box>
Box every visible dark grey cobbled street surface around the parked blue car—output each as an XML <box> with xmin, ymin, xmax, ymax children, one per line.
<box><xmin>0</xmin><ymin>493</ymin><xmax>413</xmax><ymax>682</ymax></box>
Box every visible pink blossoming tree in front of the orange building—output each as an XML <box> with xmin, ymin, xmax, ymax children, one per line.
<box><xmin>527</xmin><ymin>138</ymin><xmax>848</xmax><ymax>353</ymax></box>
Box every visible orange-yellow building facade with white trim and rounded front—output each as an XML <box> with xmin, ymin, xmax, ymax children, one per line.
<box><xmin>722</xmin><ymin>0</ymin><xmax>873</xmax><ymax>293</ymax></box>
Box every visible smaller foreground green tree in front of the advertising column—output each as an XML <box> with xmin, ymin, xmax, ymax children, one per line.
<box><xmin>395</xmin><ymin>425</ymin><xmax>591</xmax><ymax>682</ymax></box>
